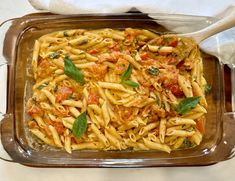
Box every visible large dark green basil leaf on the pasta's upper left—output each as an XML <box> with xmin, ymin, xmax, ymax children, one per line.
<box><xmin>64</xmin><ymin>57</ymin><xmax>85</xmax><ymax>85</ymax></box>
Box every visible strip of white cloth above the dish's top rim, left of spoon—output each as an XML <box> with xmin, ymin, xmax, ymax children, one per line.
<box><xmin>29</xmin><ymin>0</ymin><xmax>235</xmax><ymax>16</ymax></box>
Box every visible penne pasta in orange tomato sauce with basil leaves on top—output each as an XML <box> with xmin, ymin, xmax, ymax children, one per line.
<box><xmin>27</xmin><ymin>28</ymin><xmax>207</xmax><ymax>153</ymax></box>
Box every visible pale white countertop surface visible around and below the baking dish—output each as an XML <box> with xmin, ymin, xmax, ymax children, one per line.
<box><xmin>0</xmin><ymin>0</ymin><xmax>235</xmax><ymax>181</ymax></box>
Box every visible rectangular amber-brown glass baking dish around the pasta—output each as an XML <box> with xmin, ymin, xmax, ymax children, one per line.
<box><xmin>0</xmin><ymin>13</ymin><xmax>235</xmax><ymax>167</ymax></box>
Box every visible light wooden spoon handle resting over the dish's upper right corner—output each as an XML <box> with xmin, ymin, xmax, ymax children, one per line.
<box><xmin>184</xmin><ymin>7</ymin><xmax>235</xmax><ymax>43</ymax></box>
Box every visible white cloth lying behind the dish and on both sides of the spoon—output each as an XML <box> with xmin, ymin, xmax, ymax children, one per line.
<box><xmin>29</xmin><ymin>0</ymin><xmax>235</xmax><ymax>67</ymax></box>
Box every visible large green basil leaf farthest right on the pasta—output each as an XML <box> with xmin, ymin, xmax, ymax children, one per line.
<box><xmin>177</xmin><ymin>96</ymin><xmax>201</xmax><ymax>114</ymax></box>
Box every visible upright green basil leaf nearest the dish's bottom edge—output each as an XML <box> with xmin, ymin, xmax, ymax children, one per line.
<box><xmin>72</xmin><ymin>112</ymin><xmax>87</xmax><ymax>138</ymax></box>
